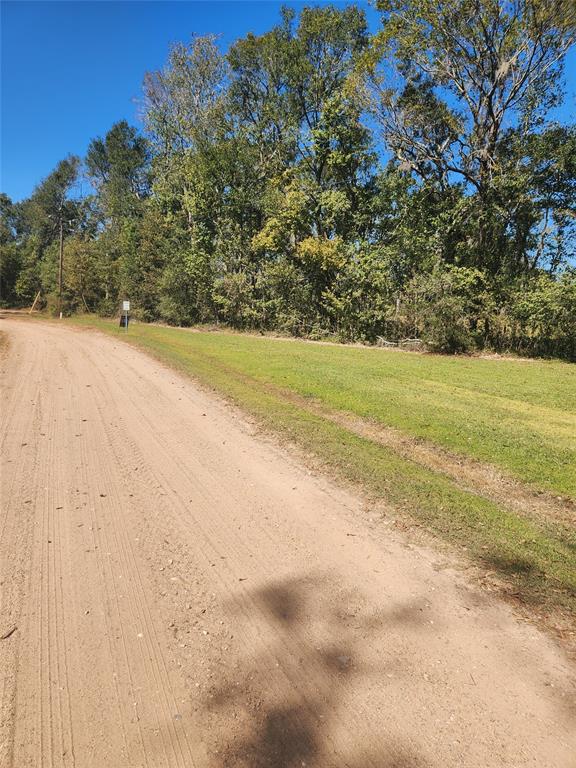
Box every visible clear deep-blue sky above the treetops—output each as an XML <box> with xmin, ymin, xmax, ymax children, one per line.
<box><xmin>0</xmin><ymin>0</ymin><xmax>576</xmax><ymax>200</ymax></box>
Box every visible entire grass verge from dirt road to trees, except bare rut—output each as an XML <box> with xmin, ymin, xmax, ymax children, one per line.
<box><xmin>73</xmin><ymin>317</ymin><xmax>576</xmax><ymax>624</ymax></box>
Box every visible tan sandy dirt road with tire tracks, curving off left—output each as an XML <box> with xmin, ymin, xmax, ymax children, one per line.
<box><xmin>0</xmin><ymin>319</ymin><xmax>576</xmax><ymax>768</ymax></box>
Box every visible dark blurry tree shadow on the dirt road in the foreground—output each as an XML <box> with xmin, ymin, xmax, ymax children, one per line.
<box><xmin>204</xmin><ymin>576</ymin><xmax>426</xmax><ymax>768</ymax></box>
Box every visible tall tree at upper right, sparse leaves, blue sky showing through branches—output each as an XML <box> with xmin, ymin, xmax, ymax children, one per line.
<box><xmin>364</xmin><ymin>0</ymin><xmax>576</xmax><ymax>273</ymax></box>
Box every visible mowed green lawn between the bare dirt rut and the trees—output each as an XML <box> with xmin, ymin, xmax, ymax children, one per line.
<box><xmin>196</xmin><ymin>334</ymin><xmax>576</xmax><ymax>499</ymax></box>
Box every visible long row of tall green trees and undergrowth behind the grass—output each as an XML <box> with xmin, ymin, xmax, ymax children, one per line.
<box><xmin>0</xmin><ymin>0</ymin><xmax>576</xmax><ymax>360</ymax></box>
